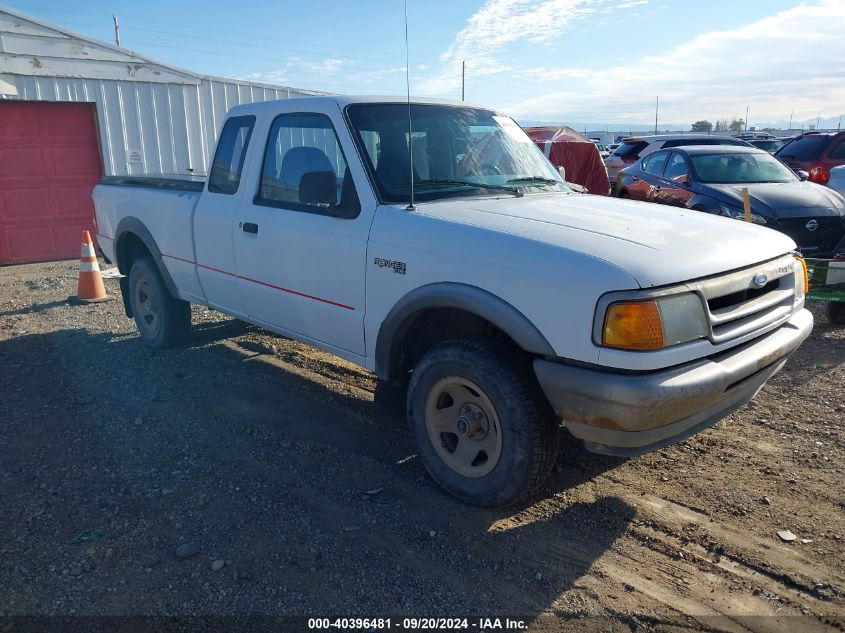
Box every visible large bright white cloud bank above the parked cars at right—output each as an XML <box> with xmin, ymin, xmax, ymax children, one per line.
<box><xmin>498</xmin><ymin>0</ymin><xmax>845</xmax><ymax>124</ymax></box>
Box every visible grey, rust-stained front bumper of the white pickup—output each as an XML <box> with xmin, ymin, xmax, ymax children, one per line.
<box><xmin>534</xmin><ymin>310</ymin><xmax>813</xmax><ymax>457</ymax></box>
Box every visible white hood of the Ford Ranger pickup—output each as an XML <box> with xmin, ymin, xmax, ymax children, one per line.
<box><xmin>416</xmin><ymin>193</ymin><xmax>796</xmax><ymax>288</ymax></box>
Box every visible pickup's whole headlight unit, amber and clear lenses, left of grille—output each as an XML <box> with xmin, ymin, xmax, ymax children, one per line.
<box><xmin>602</xmin><ymin>292</ymin><xmax>708</xmax><ymax>350</ymax></box>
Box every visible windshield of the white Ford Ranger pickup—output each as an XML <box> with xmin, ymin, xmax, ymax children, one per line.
<box><xmin>346</xmin><ymin>103</ymin><xmax>570</xmax><ymax>202</ymax></box>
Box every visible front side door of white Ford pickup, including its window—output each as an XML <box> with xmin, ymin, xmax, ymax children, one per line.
<box><xmin>232</xmin><ymin>109</ymin><xmax>372</xmax><ymax>356</ymax></box>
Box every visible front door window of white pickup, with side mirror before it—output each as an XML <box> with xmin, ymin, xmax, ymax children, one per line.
<box><xmin>255</xmin><ymin>114</ymin><xmax>361</xmax><ymax>218</ymax></box>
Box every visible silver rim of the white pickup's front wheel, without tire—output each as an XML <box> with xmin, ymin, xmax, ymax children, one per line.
<box><xmin>425</xmin><ymin>376</ymin><xmax>502</xmax><ymax>477</ymax></box>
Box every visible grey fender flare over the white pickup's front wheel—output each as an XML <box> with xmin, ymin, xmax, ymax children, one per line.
<box><xmin>375</xmin><ymin>282</ymin><xmax>557</xmax><ymax>380</ymax></box>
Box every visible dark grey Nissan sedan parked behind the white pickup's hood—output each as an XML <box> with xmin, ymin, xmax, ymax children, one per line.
<box><xmin>618</xmin><ymin>146</ymin><xmax>845</xmax><ymax>257</ymax></box>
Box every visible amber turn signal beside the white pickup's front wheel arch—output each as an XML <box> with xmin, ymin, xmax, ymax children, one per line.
<box><xmin>602</xmin><ymin>301</ymin><xmax>663</xmax><ymax>350</ymax></box>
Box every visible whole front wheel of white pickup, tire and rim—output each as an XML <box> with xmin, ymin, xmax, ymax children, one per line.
<box><xmin>408</xmin><ymin>338</ymin><xmax>560</xmax><ymax>506</ymax></box>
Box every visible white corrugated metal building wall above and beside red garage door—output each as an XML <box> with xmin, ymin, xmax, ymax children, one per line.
<box><xmin>0</xmin><ymin>75</ymin><xmax>318</xmax><ymax>175</ymax></box>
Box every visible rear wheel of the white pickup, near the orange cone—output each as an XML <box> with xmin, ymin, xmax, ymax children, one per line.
<box><xmin>129</xmin><ymin>256</ymin><xmax>191</xmax><ymax>349</ymax></box>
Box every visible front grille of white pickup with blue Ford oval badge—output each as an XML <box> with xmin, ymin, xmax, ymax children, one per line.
<box><xmin>687</xmin><ymin>255</ymin><xmax>803</xmax><ymax>344</ymax></box>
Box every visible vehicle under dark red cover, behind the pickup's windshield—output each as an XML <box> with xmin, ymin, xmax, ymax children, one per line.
<box><xmin>523</xmin><ymin>126</ymin><xmax>610</xmax><ymax>196</ymax></box>
